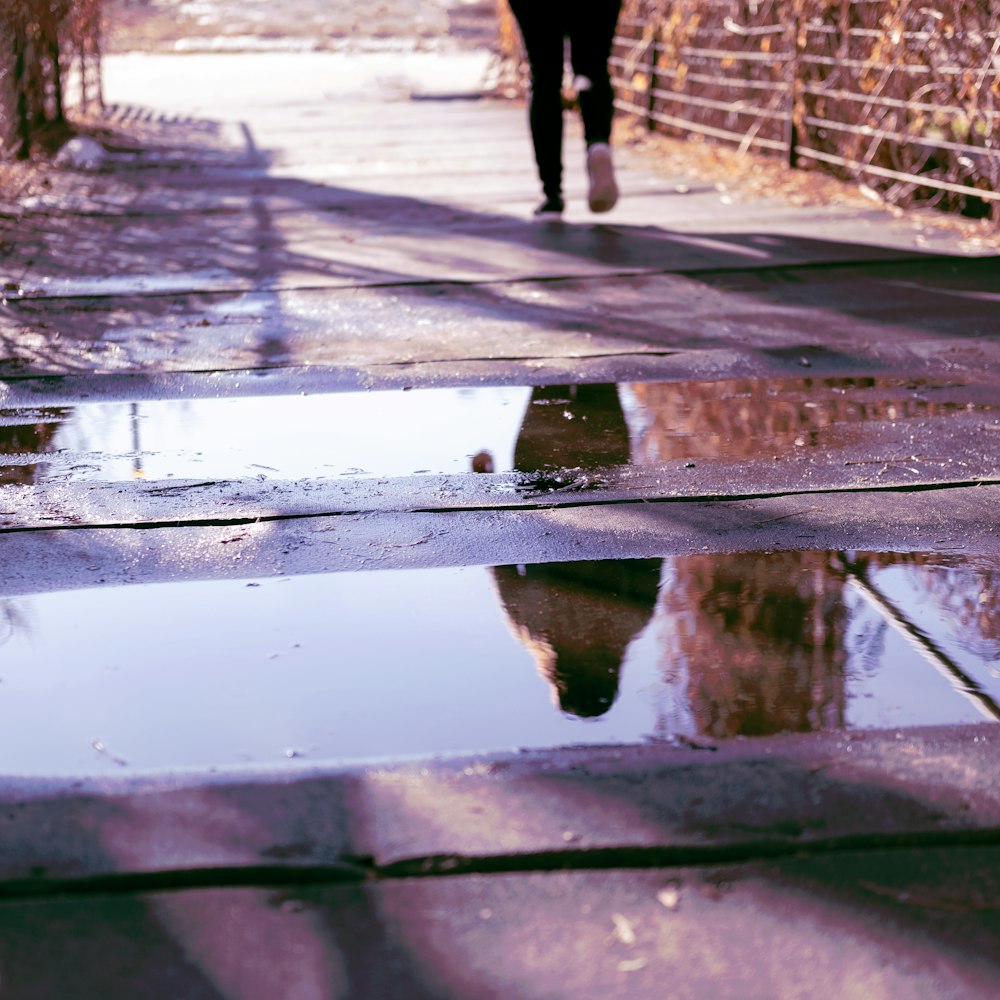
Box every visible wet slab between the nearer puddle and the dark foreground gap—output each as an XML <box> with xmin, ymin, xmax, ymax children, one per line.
<box><xmin>0</xmin><ymin>725</ymin><xmax>1000</xmax><ymax>876</ymax></box>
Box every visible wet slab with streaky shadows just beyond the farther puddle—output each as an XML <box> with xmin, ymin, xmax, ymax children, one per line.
<box><xmin>0</xmin><ymin>256</ymin><xmax>1000</xmax><ymax>381</ymax></box>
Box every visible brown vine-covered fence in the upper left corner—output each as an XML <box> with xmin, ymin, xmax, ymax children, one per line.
<box><xmin>0</xmin><ymin>0</ymin><xmax>103</xmax><ymax>158</ymax></box>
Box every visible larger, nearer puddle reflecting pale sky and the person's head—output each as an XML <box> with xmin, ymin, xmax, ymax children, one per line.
<box><xmin>0</xmin><ymin>552</ymin><xmax>1000</xmax><ymax>774</ymax></box>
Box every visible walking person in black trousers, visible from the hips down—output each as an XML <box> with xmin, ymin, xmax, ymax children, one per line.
<box><xmin>509</xmin><ymin>0</ymin><xmax>622</xmax><ymax>221</ymax></box>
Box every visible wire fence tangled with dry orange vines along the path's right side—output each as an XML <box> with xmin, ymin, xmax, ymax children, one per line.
<box><xmin>498</xmin><ymin>0</ymin><xmax>1000</xmax><ymax>218</ymax></box>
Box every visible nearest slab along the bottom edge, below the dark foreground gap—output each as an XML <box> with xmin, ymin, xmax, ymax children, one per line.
<box><xmin>0</xmin><ymin>848</ymin><xmax>997</xmax><ymax>1000</ymax></box>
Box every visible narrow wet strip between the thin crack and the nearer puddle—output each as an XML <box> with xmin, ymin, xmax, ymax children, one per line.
<box><xmin>0</xmin><ymin>486</ymin><xmax>1000</xmax><ymax>597</ymax></box>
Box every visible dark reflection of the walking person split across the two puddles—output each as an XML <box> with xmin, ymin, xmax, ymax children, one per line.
<box><xmin>493</xmin><ymin>384</ymin><xmax>661</xmax><ymax>719</ymax></box>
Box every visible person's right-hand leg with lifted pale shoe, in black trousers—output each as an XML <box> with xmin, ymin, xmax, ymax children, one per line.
<box><xmin>570</xmin><ymin>0</ymin><xmax>621</xmax><ymax>212</ymax></box>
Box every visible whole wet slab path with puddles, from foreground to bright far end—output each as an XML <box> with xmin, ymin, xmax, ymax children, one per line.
<box><xmin>0</xmin><ymin>5</ymin><xmax>1000</xmax><ymax>1000</ymax></box>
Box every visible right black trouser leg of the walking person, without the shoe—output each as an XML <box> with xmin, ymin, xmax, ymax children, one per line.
<box><xmin>569</xmin><ymin>0</ymin><xmax>622</xmax><ymax>146</ymax></box>
